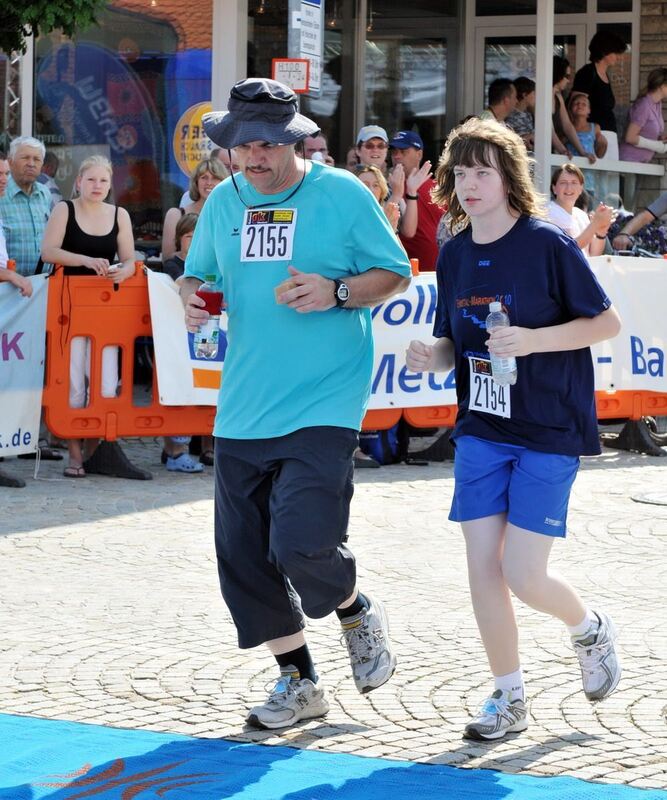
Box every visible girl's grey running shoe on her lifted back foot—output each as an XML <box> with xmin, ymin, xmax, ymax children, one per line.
<box><xmin>572</xmin><ymin>611</ymin><xmax>621</xmax><ymax>702</ymax></box>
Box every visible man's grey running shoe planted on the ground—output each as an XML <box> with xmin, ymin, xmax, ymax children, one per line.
<box><xmin>246</xmin><ymin>666</ymin><xmax>329</xmax><ymax>729</ymax></box>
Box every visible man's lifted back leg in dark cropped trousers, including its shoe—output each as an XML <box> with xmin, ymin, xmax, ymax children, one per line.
<box><xmin>270</xmin><ymin>427</ymin><xmax>396</xmax><ymax>693</ymax></box>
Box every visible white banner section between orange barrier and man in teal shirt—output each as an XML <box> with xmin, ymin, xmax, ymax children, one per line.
<box><xmin>147</xmin><ymin>269</ymin><xmax>227</xmax><ymax>406</ymax></box>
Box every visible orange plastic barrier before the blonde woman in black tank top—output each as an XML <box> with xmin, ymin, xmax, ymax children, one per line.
<box><xmin>43</xmin><ymin>269</ymin><xmax>215</xmax><ymax>441</ymax></box>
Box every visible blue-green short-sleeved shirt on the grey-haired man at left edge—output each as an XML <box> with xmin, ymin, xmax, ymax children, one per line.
<box><xmin>0</xmin><ymin>175</ymin><xmax>51</xmax><ymax>275</ymax></box>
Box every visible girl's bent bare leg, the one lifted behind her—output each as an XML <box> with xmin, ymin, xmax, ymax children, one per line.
<box><xmin>502</xmin><ymin>523</ymin><xmax>586</xmax><ymax>627</ymax></box>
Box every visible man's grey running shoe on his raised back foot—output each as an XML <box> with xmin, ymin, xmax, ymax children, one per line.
<box><xmin>340</xmin><ymin>595</ymin><xmax>396</xmax><ymax>694</ymax></box>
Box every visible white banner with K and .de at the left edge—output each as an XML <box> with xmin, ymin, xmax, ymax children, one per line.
<box><xmin>0</xmin><ymin>275</ymin><xmax>47</xmax><ymax>456</ymax></box>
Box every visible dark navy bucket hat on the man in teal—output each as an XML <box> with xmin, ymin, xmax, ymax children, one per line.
<box><xmin>202</xmin><ymin>78</ymin><xmax>320</xmax><ymax>149</ymax></box>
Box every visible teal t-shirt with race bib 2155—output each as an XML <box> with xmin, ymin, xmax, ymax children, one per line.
<box><xmin>185</xmin><ymin>162</ymin><xmax>410</xmax><ymax>439</ymax></box>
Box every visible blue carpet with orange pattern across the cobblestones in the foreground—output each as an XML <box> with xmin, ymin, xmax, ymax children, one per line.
<box><xmin>0</xmin><ymin>714</ymin><xmax>667</xmax><ymax>800</ymax></box>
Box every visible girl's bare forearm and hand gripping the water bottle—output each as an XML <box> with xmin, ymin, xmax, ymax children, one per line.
<box><xmin>486</xmin><ymin>306</ymin><xmax>621</xmax><ymax>358</ymax></box>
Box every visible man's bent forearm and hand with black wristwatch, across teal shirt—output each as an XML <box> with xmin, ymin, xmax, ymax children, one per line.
<box><xmin>277</xmin><ymin>267</ymin><xmax>410</xmax><ymax>314</ymax></box>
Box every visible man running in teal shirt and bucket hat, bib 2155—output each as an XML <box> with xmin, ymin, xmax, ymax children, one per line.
<box><xmin>181</xmin><ymin>78</ymin><xmax>410</xmax><ymax>728</ymax></box>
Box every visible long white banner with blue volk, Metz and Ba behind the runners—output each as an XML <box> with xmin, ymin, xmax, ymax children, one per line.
<box><xmin>148</xmin><ymin>256</ymin><xmax>667</xmax><ymax>409</ymax></box>
